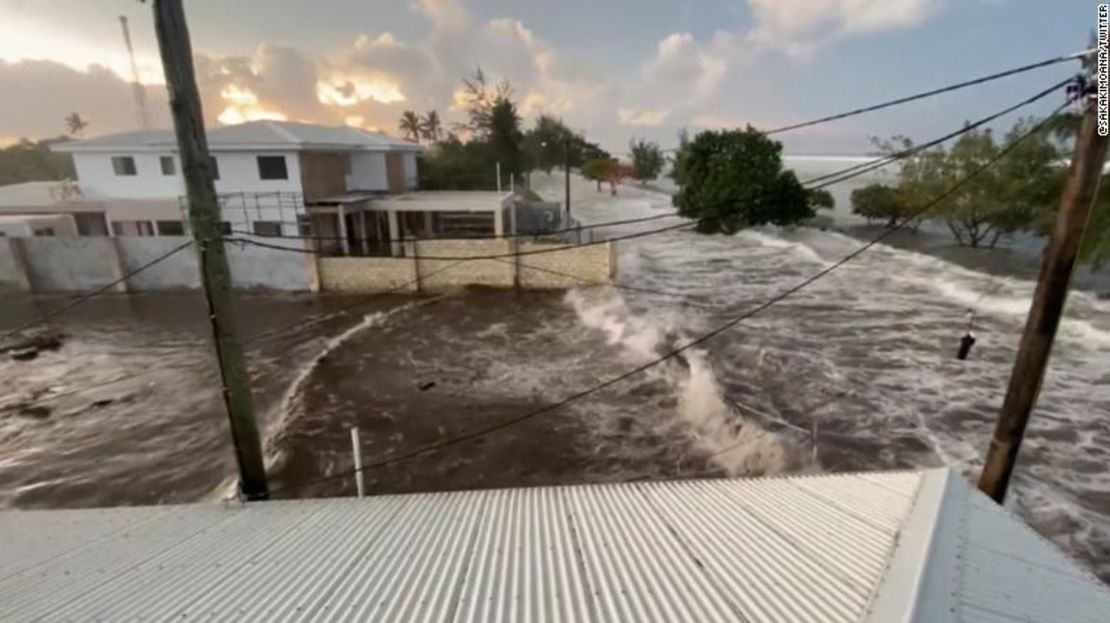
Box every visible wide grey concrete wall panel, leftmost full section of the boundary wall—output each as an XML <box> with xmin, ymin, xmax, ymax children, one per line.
<box><xmin>11</xmin><ymin>238</ymin><xmax>127</xmax><ymax>292</ymax></box>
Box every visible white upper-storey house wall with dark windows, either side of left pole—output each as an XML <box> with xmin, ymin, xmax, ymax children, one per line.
<box><xmin>73</xmin><ymin>152</ymin><xmax>301</xmax><ymax>200</ymax></box>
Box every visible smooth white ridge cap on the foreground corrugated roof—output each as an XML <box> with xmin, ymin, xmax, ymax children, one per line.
<box><xmin>862</xmin><ymin>468</ymin><xmax>958</xmax><ymax>623</ymax></box>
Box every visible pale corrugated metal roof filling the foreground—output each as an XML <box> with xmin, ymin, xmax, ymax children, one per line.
<box><xmin>0</xmin><ymin>470</ymin><xmax>1110</xmax><ymax>622</ymax></box>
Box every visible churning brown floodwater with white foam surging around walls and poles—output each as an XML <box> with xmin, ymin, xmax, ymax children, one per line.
<box><xmin>0</xmin><ymin>175</ymin><xmax>1110</xmax><ymax>579</ymax></box>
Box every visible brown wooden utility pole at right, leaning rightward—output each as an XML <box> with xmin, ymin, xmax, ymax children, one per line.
<box><xmin>979</xmin><ymin>82</ymin><xmax>1108</xmax><ymax>504</ymax></box>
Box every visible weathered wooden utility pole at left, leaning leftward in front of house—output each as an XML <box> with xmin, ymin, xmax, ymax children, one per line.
<box><xmin>153</xmin><ymin>0</ymin><xmax>270</xmax><ymax>500</ymax></box>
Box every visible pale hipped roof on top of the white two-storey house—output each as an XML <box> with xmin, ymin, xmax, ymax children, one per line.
<box><xmin>51</xmin><ymin>120</ymin><xmax>424</xmax><ymax>153</ymax></box>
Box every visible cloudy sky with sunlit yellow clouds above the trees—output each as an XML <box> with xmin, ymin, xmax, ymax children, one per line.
<box><xmin>0</xmin><ymin>0</ymin><xmax>1096</xmax><ymax>153</ymax></box>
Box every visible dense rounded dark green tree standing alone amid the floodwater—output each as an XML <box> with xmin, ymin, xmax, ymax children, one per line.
<box><xmin>674</xmin><ymin>125</ymin><xmax>816</xmax><ymax>233</ymax></box>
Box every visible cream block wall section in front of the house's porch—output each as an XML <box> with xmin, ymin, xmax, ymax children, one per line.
<box><xmin>317</xmin><ymin>239</ymin><xmax>615</xmax><ymax>292</ymax></box>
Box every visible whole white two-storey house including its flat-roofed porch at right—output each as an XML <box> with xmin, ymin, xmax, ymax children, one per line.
<box><xmin>0</xmin><ymin>121</ymin><xmax>532</xmax><ymax>254</ymax></box>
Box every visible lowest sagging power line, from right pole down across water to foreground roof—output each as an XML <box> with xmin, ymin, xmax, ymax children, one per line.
<box><xmin>268</xmin><ymin>103</ymin><xmax>1068</xmax><ymax>495</ymax></box>
